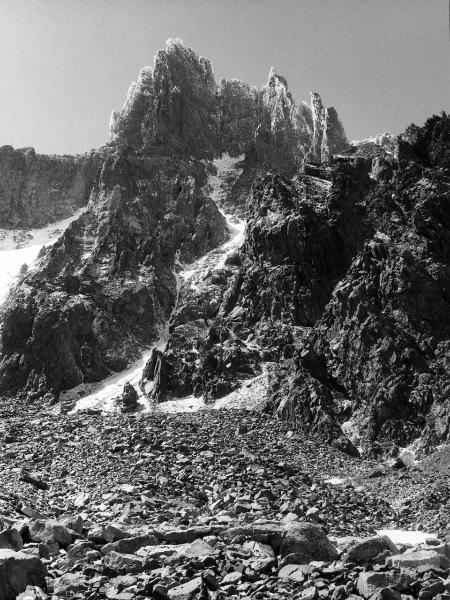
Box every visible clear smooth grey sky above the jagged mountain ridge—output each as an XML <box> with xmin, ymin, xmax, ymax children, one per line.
<box><xmin>0</xmin><ymin>0</ymin><xmax>450</xmax><ymax>153</ymax></box>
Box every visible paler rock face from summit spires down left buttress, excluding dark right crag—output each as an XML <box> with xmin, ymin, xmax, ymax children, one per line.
<box><xmin>0</xmin><ymin>40</ymin><xmax>348</xmax><ymax>399</ymax></box>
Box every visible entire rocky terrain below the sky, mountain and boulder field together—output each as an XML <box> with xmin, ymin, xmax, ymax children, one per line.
<box><xmin>0</xmin><ymin>39</ymin><xmax>450</xmax><ymax>600</ymax></box>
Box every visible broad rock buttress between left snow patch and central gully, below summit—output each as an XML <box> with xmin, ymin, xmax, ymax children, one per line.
<box><xmin>0</xmin><ymin>150</ymin><xmax>226</xmax><ymax>397</ymax></box>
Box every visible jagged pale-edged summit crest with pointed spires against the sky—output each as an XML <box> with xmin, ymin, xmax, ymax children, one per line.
<box><xmin>110</xmin><ymin>39</ymin><xmax>348</xmax><ymax>169</ymax></box>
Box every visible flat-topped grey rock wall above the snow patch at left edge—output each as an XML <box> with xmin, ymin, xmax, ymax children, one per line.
<box><xmin>0</xmin><ymin>146</ymin><xmax>100</xmax><ymax>229</ymax></box>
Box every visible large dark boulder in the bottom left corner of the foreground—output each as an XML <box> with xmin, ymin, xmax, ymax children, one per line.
<box><xmin>0</xmin><ymin>549</ymin><xmax>47</xmax><ymax>600</ymax></box>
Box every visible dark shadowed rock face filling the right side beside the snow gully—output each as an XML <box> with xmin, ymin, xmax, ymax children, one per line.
<box><xmin>154</xmin><ymin>115</ymin><xmax>450</xmax><ymax>452</ymax></box>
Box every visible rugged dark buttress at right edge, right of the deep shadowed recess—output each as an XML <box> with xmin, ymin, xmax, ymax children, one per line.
<box><xmin>273</xmin><ymin>115</ymin><xmax>450</xmax><ymax>451</ymax></box>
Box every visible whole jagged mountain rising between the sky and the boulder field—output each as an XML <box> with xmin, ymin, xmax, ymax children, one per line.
<box><xmin>0</xmin><ymin>40</ymin><xmax>450</xmax><ymax>454</ymax></box>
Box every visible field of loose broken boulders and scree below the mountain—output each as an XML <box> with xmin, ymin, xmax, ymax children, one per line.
<box><xmin>0</xmin><ymin>404</ymin><xmax>450</xmax><ymax>600</ymax></box>
